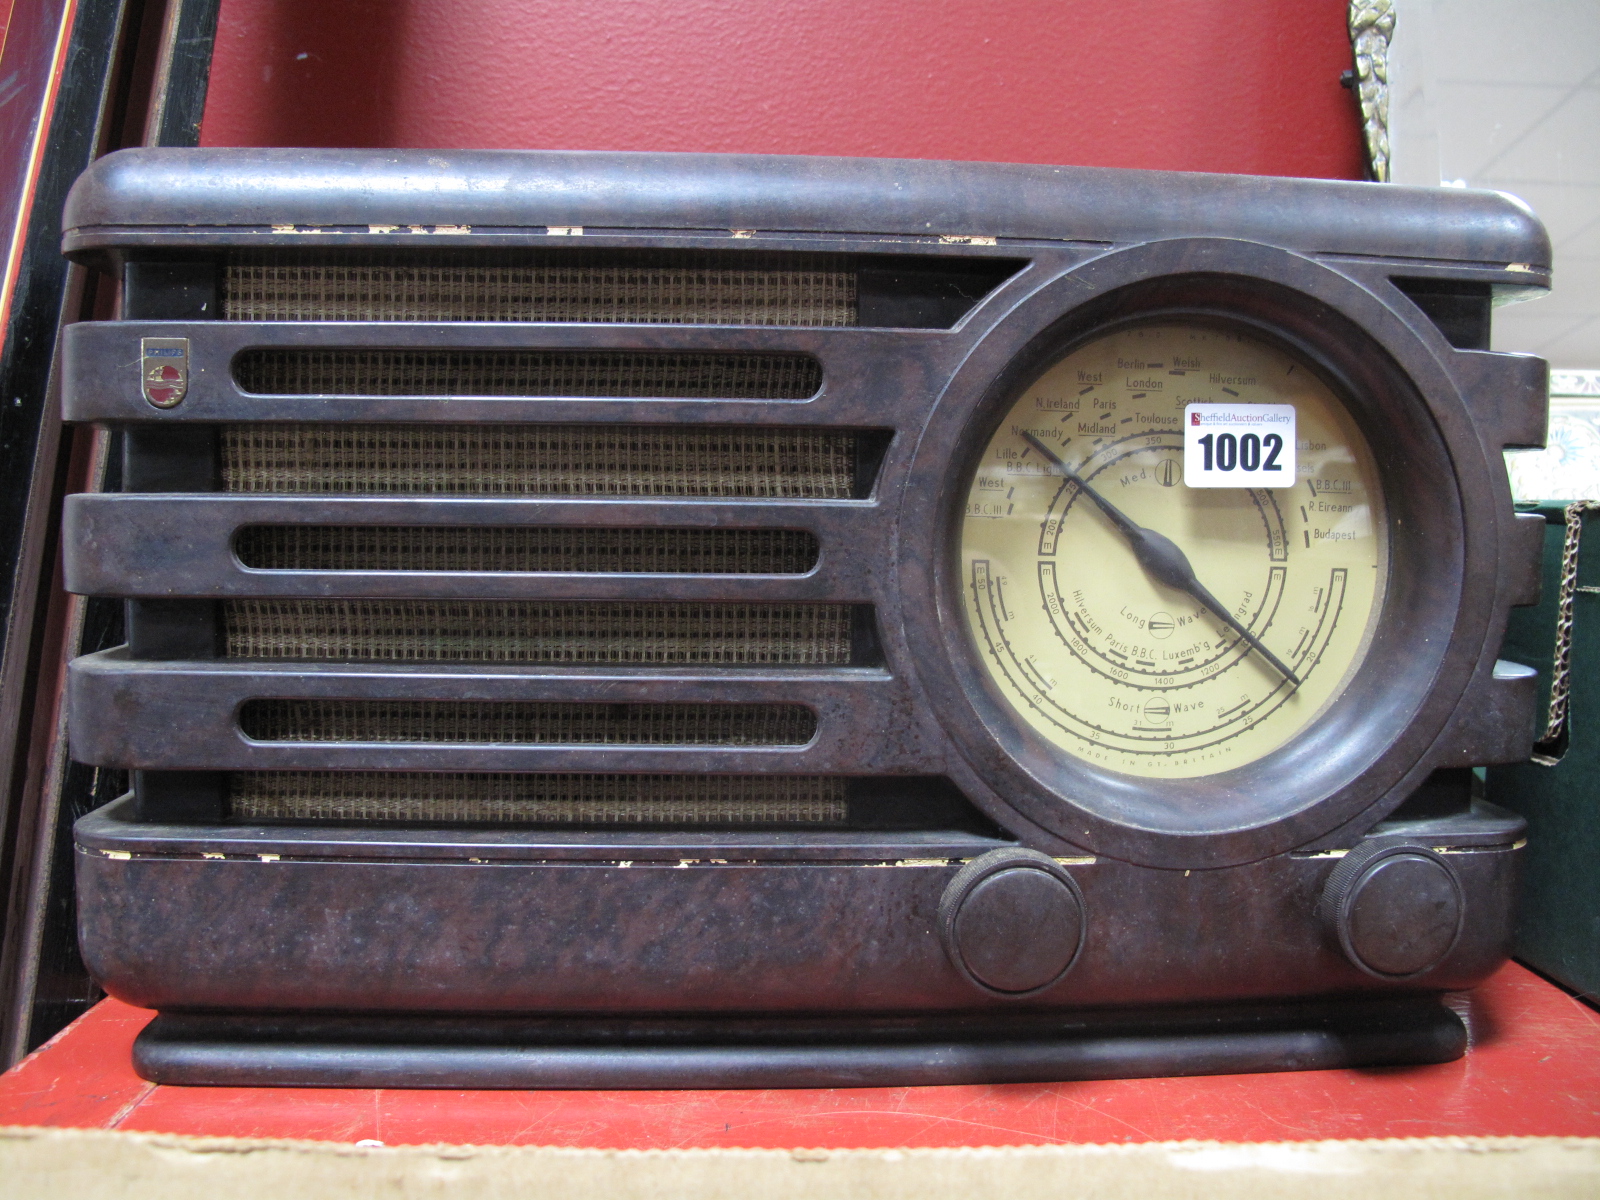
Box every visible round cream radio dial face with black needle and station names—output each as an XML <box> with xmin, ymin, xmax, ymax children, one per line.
<box><xmin>960</xmin><ymin>323</ymin><xmax>1389</xmax><ymax>779</ymax></box>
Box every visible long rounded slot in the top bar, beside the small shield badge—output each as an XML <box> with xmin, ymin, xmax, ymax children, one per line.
<box><xmin>234</xmin><ymin>349</ymin><xmax>822</xmax><ymax>400</ymax></box>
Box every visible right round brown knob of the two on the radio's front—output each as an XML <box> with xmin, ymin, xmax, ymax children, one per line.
<box><xmin>1318</xmin><ymin>845</ymin><xmax>1466</xmax><ymax>979</ymax></box>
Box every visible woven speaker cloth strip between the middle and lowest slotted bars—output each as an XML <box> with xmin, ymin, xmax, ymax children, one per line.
<box><xmin>222</xmin><ymin>598</ymin><xmax>851</xmax><ymax>666</ymax></box>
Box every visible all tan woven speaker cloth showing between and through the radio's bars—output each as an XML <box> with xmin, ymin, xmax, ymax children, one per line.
<box><xmin>219</xmin><ymin>248</ymin><xmax>861</xmax><ymax>826</ymax></box>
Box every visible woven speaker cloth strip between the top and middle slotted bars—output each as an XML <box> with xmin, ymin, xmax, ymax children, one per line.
<box><xmin>222</xmin><ymin>424</ymin><xmax>859</xmax><ymax>499</ymax></box>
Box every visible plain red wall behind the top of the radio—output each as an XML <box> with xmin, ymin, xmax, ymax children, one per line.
<box><xmin>202</xmin><ymin>0</ymin><xmax>1360</xmax><ymax>178</ymax></box>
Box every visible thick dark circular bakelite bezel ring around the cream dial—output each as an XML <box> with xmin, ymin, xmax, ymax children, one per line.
<box><xmin>899</xmin><ymin>238</ymin><xmax>1498</xmax><ymax>867</ymax></box>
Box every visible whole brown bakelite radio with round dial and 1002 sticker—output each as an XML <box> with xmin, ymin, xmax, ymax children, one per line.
<box><xmin>62</xmin><ymin>150</ymin><xmax>1549</xmax><ymax>1086</ymax></box>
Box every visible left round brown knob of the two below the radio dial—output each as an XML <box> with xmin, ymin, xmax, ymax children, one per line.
<box><xmin>939</xmin><ymin>850</ymin><xmax>1083</xmax><ymax>995</ymax></box>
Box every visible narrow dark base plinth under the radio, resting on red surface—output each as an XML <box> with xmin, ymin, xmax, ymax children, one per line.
<box><xmin>134</xmin><ymin>997</ymin><xmax>1467</xmax><ymax>1090</ymax></box>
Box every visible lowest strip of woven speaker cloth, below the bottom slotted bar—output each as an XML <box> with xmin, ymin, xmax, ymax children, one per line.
<box><xmin>227</xmin><ymin>771</ymin><xmax>846</xmax><ymax>826</ymax></box>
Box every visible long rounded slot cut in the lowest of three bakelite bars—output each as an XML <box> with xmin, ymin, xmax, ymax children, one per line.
<box><xmin>238</xmin><ymin>699</ymin><xmax>816</xmax><ymax>746</ymax></box>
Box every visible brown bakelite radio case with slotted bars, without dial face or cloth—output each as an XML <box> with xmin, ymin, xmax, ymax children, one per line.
<box><xmin>62</xmin><ymin>150</ymin><xmax>1550</xmax><ymax>1086</ymax></box>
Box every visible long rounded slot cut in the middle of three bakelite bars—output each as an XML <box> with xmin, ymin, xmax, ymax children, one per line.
<box><xmin>234</xmin><ymin>525</ymin><xmax>818</xmax><ymax>574</ymax></box>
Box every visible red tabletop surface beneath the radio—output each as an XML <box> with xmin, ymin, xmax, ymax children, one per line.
<box><xmin>0</xmin><ymin>965</ymin><xmax>1600</xmax><ymax>1149</ymax></box>
